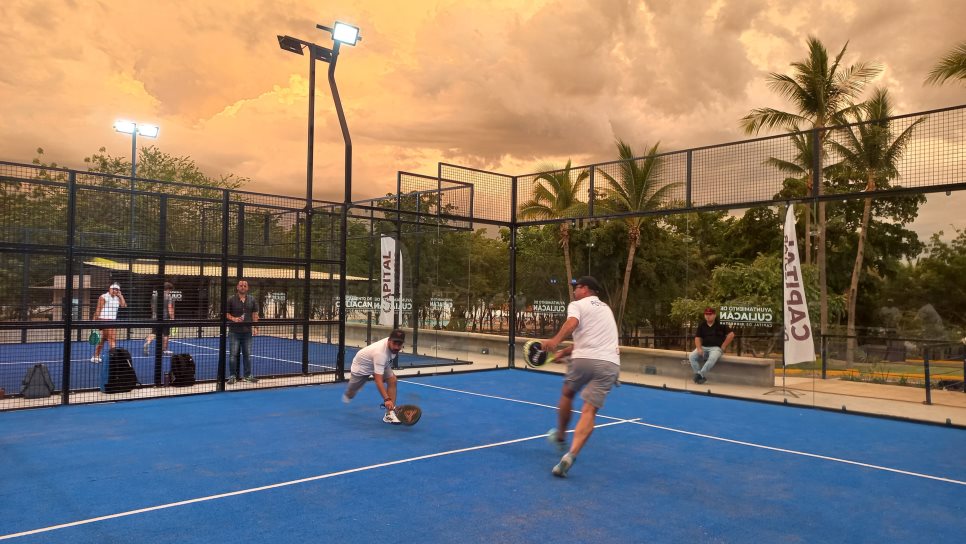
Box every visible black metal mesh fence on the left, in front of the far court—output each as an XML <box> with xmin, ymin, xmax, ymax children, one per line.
<box><xmin>0</xmin><ymin>163</ymin><xmax>344</xmax><ymax>408</ymax></box>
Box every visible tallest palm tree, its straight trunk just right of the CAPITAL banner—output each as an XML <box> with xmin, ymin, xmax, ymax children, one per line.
<box><xmin>741</xmin><ymin>36</ymin><xmax>882</xmax><ymax>334</ymax></box>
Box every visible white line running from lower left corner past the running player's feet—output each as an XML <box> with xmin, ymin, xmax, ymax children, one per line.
<box><xmin>0</xmin><ymin>418</ymin><xmax>640</xmax><ymax>540</ymax></box>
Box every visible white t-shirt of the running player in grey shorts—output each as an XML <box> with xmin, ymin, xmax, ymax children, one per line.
<box><xmin>567</xmin><ymin>295</ymin><xmax>621</xmax><ymax>366</ymax></box>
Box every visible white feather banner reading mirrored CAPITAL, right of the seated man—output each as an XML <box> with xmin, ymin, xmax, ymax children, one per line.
<box><xmin>782</xmin><ymin>204</ymin><xmax>815</xmax><ymax>365</ymax></box>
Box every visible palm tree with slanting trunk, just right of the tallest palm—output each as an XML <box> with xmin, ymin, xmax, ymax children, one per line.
<box><xmin>830</xmin><ymin>88</ymin><xmax>925</xmax><ymax>363</ymax></box>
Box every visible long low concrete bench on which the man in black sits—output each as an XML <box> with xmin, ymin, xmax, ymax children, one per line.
<box><xmin>621</xmin><ymin>347</ymin><xmax>775</xmax><ymax>387</ymax></box>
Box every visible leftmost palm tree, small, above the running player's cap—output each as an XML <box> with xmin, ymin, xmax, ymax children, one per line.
<box><xmin>520</xmin><ymin>160</ymin><xmax>590</xmax><ymax>301</ymax></box>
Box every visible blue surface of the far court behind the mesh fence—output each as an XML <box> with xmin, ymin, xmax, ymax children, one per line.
<box><xmin>0</xmin><ymin>336</ymin><xmax>469</xmax><ymax>392</ymax></box>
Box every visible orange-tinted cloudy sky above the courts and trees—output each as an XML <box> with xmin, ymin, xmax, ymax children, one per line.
<box><xmin>0</xmin><ymin>0</ymin><xmax>966</xmax><ymax>222</ymax></box>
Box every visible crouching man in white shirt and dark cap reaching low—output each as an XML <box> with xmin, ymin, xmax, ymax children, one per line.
<box><xmin>342</xmin><ymin>329</ymin><xmax>406</xmax><ymax>425</ymax></box>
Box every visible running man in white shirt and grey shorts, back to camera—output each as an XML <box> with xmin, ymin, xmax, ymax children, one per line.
<box><xmin>541</xmin><ymin>276</ymin><xmax>621</xmax><ymax>478</ymax></box>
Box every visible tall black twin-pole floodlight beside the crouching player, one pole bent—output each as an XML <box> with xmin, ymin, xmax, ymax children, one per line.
<box><xmin>278</xmin><ymin>21</ymin><xmax>362</xmax><ymax>380</ymax></box>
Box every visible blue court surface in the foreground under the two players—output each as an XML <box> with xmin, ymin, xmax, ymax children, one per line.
<box><xmin>0</xmin><ymin>369</ymin><xmax>966</xmax><ymax>544</ymax></box>
